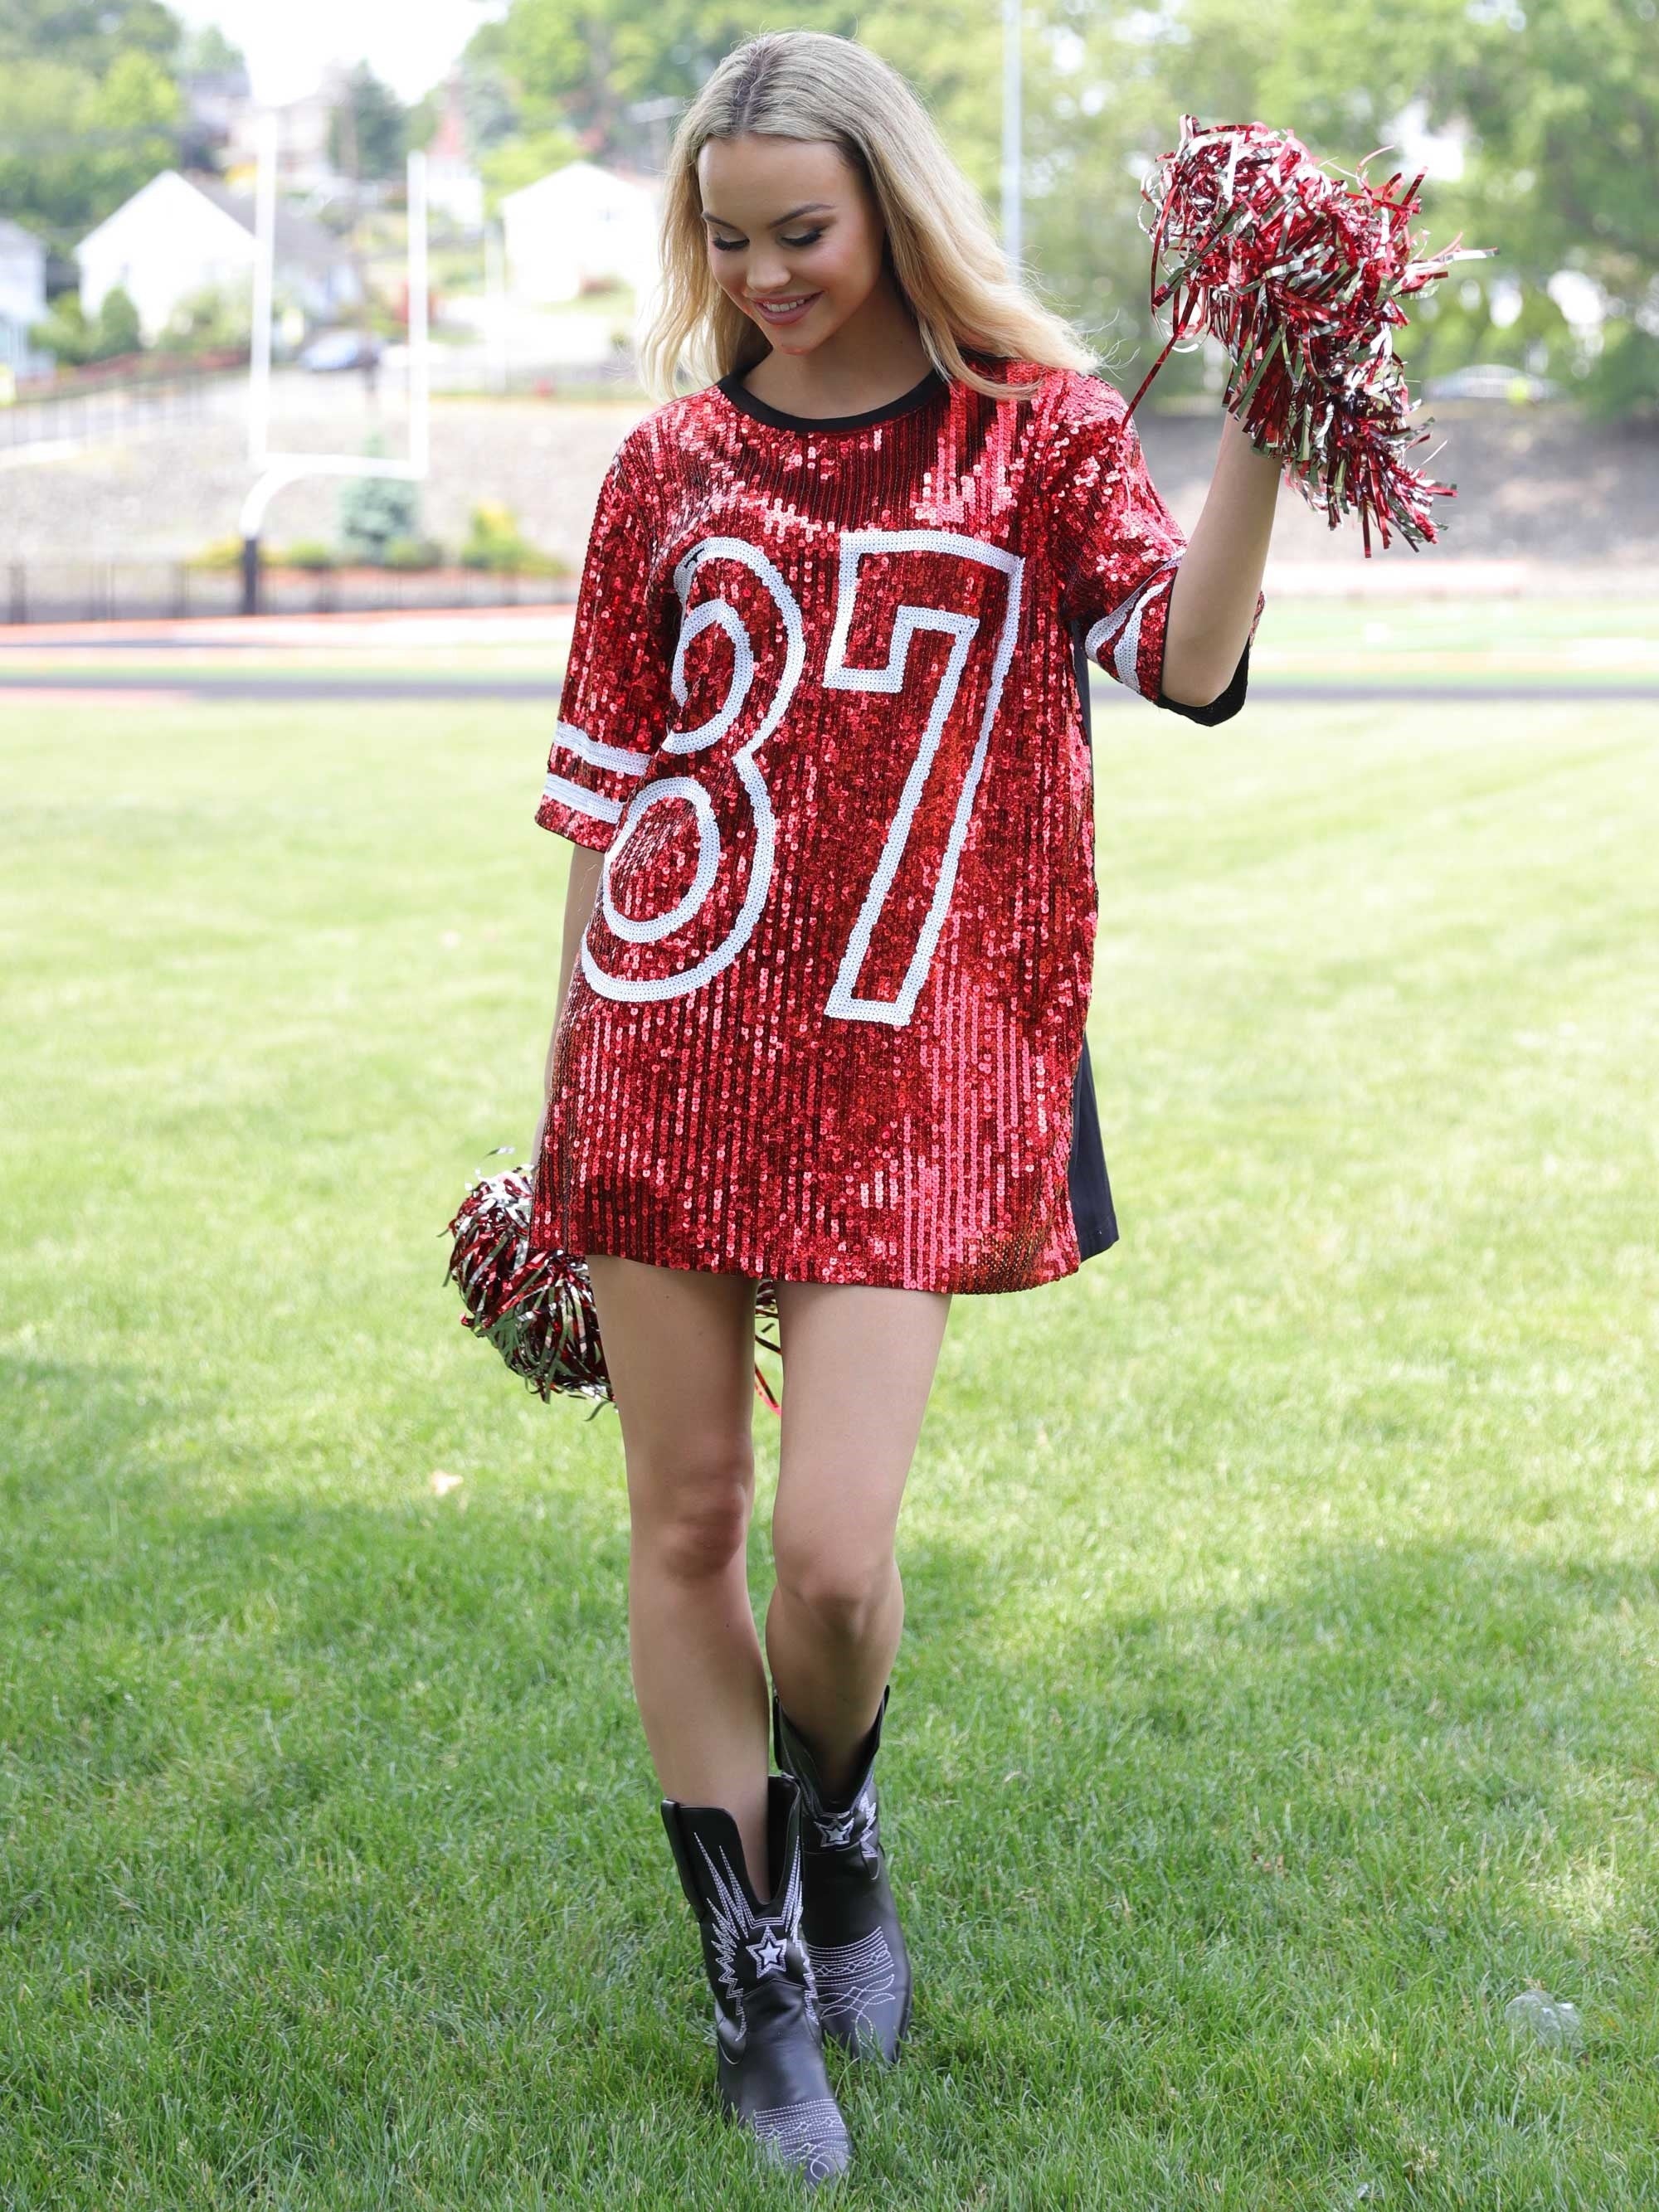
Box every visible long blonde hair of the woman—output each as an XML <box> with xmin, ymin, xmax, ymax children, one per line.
<box><xmin>640</xmin><ymin>31</ymin><xmax>1097</xmax><ymax>401</ymax></box>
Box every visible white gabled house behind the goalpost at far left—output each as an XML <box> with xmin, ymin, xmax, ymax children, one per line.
<box><xmin>75</xmin><ymin>168</ymin><xmax>361</xmax><ymax>341</ymax></box>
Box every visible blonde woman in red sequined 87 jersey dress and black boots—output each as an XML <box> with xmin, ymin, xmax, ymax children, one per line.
<box><xmin>535</xmin><ymin>31</ymin><xmax>1278</xmax><ymax>2181</ymax></box>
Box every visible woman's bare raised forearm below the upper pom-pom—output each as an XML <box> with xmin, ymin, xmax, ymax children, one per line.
<box><xmin>1164</xmin><ymin>416</ymin><xmax>1285</xmax><ymax>706</ymax></box>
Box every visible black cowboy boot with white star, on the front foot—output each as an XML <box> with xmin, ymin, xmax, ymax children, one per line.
<box><xmin>661</xmin><ymin>1774</ymin><xmax>852</xmax><ymax>2183</ymax></box>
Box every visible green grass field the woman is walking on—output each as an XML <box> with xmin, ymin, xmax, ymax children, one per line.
<box><xmin>0</xmin><ymin>703</ymin><xmax>1659</xmax><ymax>2212</ymax></box>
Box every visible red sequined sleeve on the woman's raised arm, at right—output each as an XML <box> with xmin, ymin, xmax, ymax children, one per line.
<box><xmin>1039</xmin><ymin>372</ymin><xmax>1263</xmax><ymax>723</ymax></box>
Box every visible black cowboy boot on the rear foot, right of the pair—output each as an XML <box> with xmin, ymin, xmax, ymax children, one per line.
<box><xmin>772</xmin><ymin>1684</ymin><xmax>912</xmax><ymax>2066</ymax></box>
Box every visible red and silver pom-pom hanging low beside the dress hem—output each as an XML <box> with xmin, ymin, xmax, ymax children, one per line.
<box><xmin>445</xmin><ymin>1168</ymin><xmax>781</xmax><ymax>1413</ymax></box>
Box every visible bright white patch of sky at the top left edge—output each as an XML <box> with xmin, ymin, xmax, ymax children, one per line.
<box><xmin>173</xmin><ymin>0</ymin><xmax>500</xmax><ymax>100</ymax></box>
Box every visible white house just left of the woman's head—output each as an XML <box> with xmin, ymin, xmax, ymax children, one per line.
<box><xmin>502</xmin><ymin>162</ymin><xmax>661</xmax><ymax>301</ymax></box>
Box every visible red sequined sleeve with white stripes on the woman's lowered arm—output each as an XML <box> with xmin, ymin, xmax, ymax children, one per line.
<box><xmin>535</xmin><ymin>442</ymin><xmax>674</xmax><ymax>852</ymax></box>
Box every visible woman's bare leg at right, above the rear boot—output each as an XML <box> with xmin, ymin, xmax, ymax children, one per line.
<box><xmin>766</xmin><ymin>1283</ymin><xmax>951</xmax><ymax>1794</ymax></box>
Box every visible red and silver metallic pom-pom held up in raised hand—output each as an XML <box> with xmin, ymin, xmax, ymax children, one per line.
<box><xmin>1131</xmin><ymin>115</ymin><xmax>1484</xmax><ymax>553</ymax></box>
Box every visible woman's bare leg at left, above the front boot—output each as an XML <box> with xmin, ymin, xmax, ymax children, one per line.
<box><xmin>588</xmin><ymin>1254</ymin><xmax>770</xmax><ymax>1900</ymax></box>
